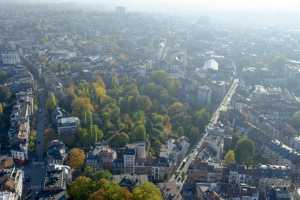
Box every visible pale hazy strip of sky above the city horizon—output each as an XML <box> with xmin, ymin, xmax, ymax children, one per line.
<box><xmin>73</xmin><ymin>0</ymin><xmax>300</xmax><ymax>11</ymax></box>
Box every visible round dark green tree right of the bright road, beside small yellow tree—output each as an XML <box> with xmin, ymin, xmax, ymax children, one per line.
<box><xmin>235</xmin><ymin>138</ymin><xmax>255</xmax><ymax>165</ymax></box>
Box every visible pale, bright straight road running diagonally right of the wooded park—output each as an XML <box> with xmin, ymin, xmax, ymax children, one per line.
<box><xmin>169</xmin><ymin>79</ymin><xmax>239</xmax><ymax>191</ymax></box>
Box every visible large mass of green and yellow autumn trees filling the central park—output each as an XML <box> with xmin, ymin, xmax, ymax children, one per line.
<box><xmin>57</xmin><ymin>70</ymin><xmax>210</xmax><ymax>156</ymax></box>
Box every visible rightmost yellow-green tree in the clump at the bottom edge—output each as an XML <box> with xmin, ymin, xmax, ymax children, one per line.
<box><xmin>132</xmin><ymin>182</ymin><xmax>162</xmax><ymax>200</ymax></box>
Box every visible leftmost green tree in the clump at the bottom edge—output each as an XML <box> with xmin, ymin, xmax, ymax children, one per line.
<box><xmin>68</xmin><ymin>176</ymin><xmax>94</xmax><ymax>200</ymax></box>
